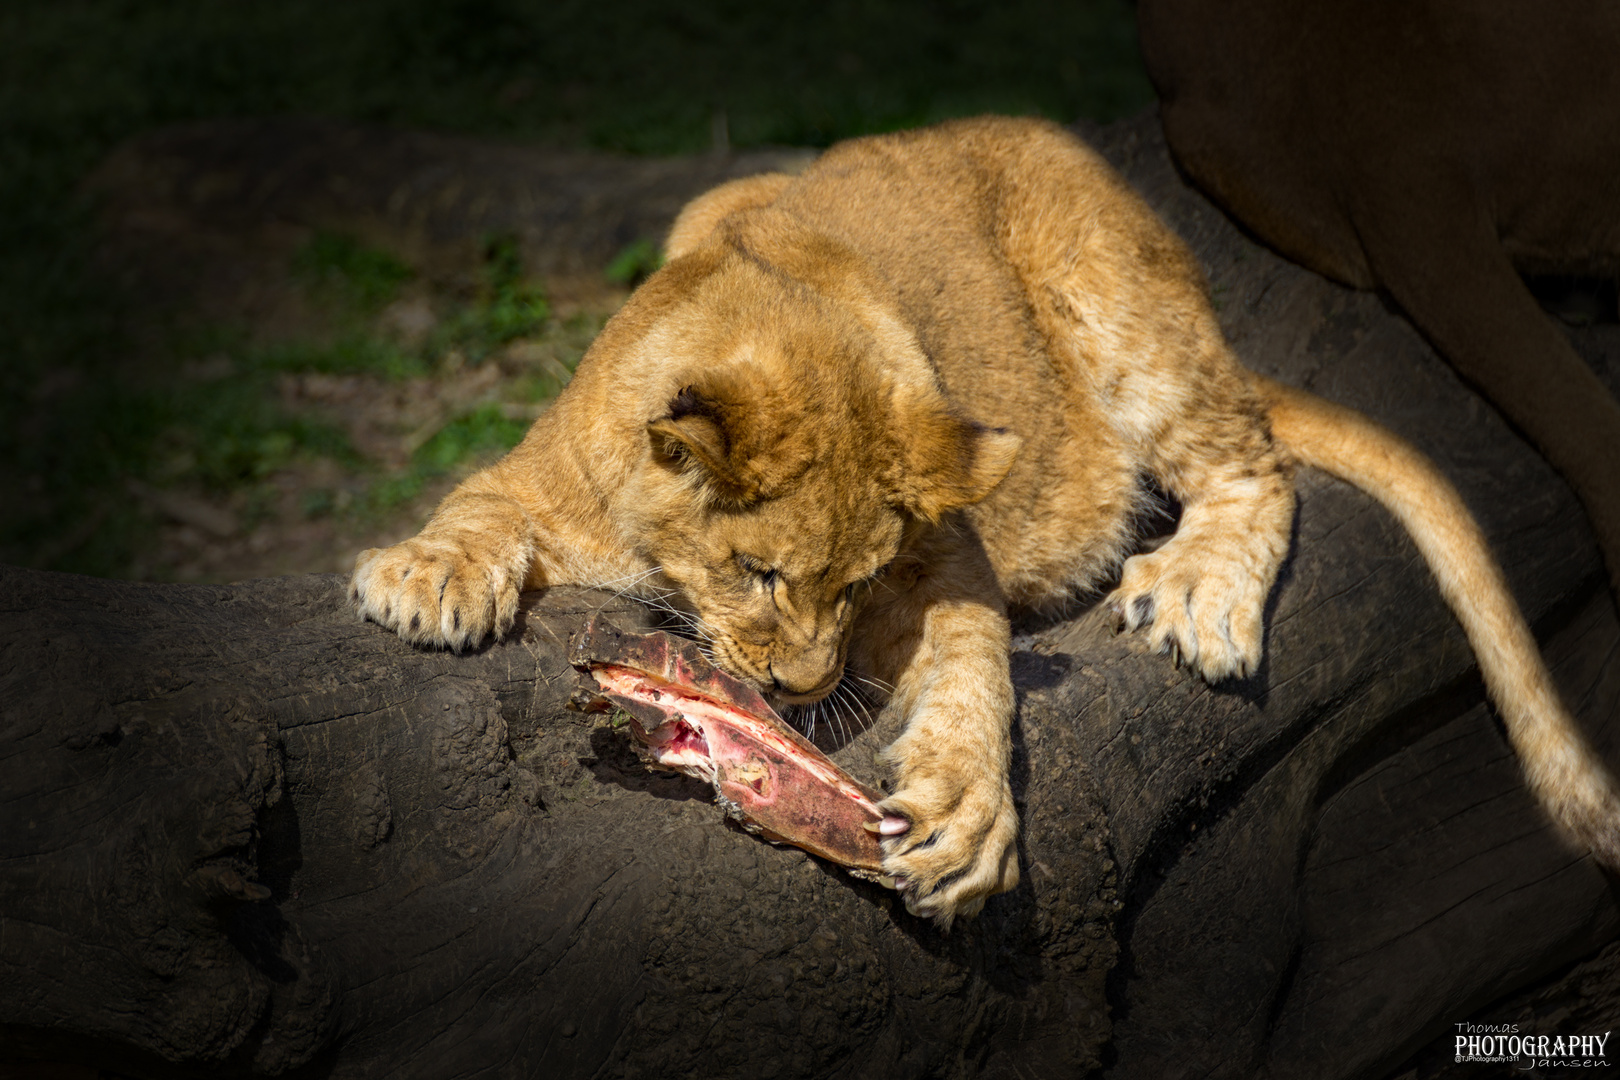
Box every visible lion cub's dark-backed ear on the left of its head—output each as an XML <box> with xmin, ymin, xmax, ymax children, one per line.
<box><xmin>646</xmin><ymin>385</ymin><xmax>813</xmax><ymax>505</ymax></box>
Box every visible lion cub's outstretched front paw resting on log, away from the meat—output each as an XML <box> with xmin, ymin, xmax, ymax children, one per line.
<box><xmin>348</xmin><ymin>536</ymin><xmax>522</xmax><ymax>651</ymax></box>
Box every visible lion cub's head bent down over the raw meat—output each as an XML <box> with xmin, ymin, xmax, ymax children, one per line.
<box><xmin>620</xmin><ymin>214</ymin><xmax>1019</xmax><ymax>703</ymax></box>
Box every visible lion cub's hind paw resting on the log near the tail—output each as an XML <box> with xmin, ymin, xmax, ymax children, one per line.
<box><xmin>1108</xmin><ymin>541</ymin><xmax>1265</xmax><ymax>682</ymax></box>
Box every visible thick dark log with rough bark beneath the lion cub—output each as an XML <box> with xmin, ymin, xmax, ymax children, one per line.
<box><xmin>0</xmin><ymin>111</ymin><xmax>1620</xmax><ymax>1080</ymax></box>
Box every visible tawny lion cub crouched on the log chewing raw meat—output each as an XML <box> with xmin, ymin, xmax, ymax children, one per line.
<box><xmin>352</xmin><ymin>118</ymin><xmax>1620</xmax><ymax>925</ymax></box>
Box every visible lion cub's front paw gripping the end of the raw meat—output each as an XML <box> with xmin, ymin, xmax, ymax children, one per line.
<box><xmin>881</xmin><ymin>748</ymin><xmax>1017</xmax><ymax>929</ymax></box>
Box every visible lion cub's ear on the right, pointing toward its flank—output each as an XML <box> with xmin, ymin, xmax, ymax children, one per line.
<box><xmin>893</xmin><ymin>402</ymin><xmax>1024</xmax><ymax>521</ymax></box>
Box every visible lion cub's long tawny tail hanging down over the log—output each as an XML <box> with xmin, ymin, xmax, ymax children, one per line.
<box><xmin>1256</xmin><ymin>376</ymin><xmax>1620</xmax><ymax>870</ymax></box>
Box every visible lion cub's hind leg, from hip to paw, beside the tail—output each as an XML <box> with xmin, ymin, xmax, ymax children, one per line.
<box><xmin>1000</xmin><ymin>126</ymin><xmax>1294</xmax><ymax>682</ymax></box>
